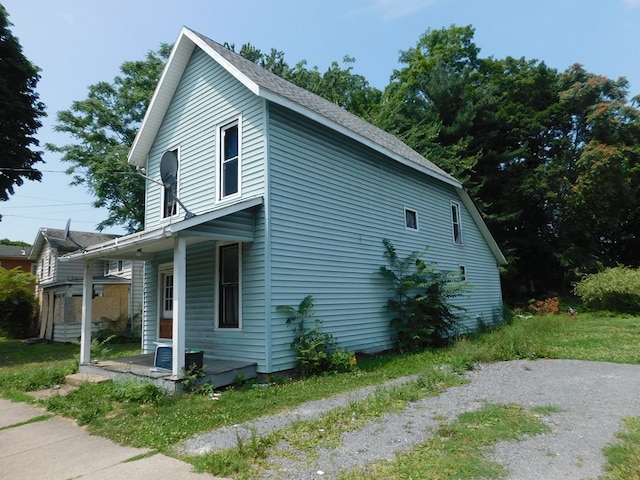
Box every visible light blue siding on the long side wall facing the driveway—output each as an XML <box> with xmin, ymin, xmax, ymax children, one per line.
<box><xmin>269</xmin><ymin>106</ymin><xmax>501</xmax><ymax>370</ymax></box>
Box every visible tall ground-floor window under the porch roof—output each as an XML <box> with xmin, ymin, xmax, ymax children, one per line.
<box><xmin>218</xmin><ymin>243</ymin><xmax>241</xmax><ymax>328</ymax></box>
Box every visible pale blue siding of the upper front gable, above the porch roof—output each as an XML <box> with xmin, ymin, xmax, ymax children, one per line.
<box><xmin>145</xmin><ymin>49</ymin><xmax>264</xmax><ymax>229</ymax></box>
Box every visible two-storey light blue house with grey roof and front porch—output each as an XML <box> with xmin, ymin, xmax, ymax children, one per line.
<box><xmin>69</xmin><ymin>28</ymin><xmax>505</xmax><ymax>386</ymax></box>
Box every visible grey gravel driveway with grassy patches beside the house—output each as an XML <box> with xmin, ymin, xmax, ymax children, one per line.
<box><xmin>179</xmin><ymin>360</ymin><xmax>640</xmax><ymax>480</ymax></box>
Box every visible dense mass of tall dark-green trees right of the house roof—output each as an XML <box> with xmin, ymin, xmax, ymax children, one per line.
<box><xmin>376</xmin><ymin>26</ymin><xmax>640</xmax><ymax>297</ymax></box>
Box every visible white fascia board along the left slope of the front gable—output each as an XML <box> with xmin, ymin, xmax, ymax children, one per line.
<box><xmin>127</xmin><ymin>27</ymin><xmax>194</xmax><ymax>167</ymax></box>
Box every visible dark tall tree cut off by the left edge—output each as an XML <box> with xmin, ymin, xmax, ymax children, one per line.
<box><xmin>0</xmin><ymin>4</ymin><xmax>46</xmax><ymax>203</ymax></box>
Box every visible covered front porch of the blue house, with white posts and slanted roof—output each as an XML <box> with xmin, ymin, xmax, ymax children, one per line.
<box><xmin>65</xmin><ymin>196</ymin><xmax>262</xmax><ymax>391</ymax></box>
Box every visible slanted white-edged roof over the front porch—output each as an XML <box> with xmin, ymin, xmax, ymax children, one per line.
<box><xmin>60</xmin><ymin>195</ymin><xmax>263</xmax><ymax>261</ymax></box>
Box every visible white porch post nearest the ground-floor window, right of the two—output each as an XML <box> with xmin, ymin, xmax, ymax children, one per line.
<box><xmin>172</xmin><ymin>235</ymin><xmax>187</xmax><ymax>376</ymax></box>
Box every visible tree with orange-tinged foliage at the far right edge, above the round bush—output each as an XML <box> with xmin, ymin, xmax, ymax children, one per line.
<box><xmin>555</xmin><ymin>64</ymin><xmax>640</xmax><ymax>273</ymax></box>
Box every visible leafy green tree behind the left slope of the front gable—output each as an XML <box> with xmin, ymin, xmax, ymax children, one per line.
<box><xmin>47</xmin><ymin>44</ymin><xmax>171</xmax><ymax>233</ymax></box>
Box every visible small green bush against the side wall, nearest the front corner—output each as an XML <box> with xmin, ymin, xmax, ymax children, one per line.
<box><xmin>278</xmin><ymin>295</ymin><xmax>355</xmax><ymax>376</ymax></box>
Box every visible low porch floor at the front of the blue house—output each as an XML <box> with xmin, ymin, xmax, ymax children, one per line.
<box><xmin>79</xmin><ymin>353</ymin><xmax>257</xmax><ymax>392</ymax></box>
